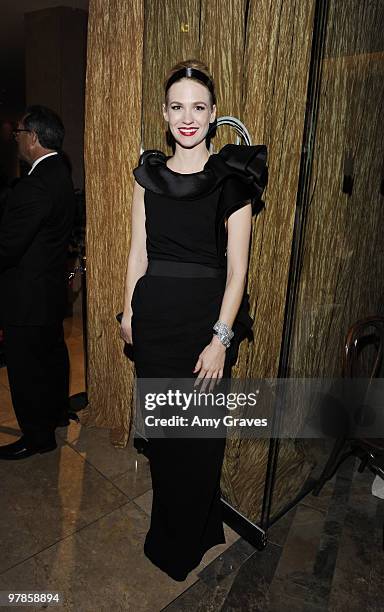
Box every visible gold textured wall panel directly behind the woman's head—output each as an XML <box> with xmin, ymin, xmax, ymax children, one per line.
<box><xmin>143</xmin><ymin>0</ymin><xmax>246</xmax><ymax>154</ymax></box>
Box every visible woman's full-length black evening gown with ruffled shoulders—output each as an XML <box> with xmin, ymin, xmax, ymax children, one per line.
<box><xmin>132</xmin><ymin>145</ymin><xmax>267</xmax><ymax>580</ymax></box>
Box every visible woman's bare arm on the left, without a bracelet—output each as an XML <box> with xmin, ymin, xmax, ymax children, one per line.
<box><xmin>120</xmin><ymin>181</ymin><xmax>148</xmax><ymax>344</ymax></box>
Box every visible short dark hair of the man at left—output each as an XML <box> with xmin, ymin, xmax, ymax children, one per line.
<box><xmin>23</xmin><ymin>104</ymin><xmax>65</xmax><ymax>150</ymax></box>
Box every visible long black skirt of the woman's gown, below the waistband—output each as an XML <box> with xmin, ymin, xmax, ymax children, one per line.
<box><xmin>132</xmin><ymin>275</ymin><xmax>230</xmax><ymax>580</ymax></box>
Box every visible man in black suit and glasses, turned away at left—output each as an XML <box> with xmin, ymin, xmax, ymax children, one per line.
<box><xmin>0</xmin><ymin>106</ymin><xmax>75</xmax><ymax>459</ymax></box>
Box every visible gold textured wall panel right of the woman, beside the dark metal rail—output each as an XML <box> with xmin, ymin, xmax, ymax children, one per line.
<box><xmin>222</xmin><ymin>0</ymin><xmax>315</xmax><ymax>522</ymax></box>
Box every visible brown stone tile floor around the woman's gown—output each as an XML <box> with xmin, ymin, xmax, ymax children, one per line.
<box><xmin>0</xmin><ymin>315</ymin><xmax>384</xmax><ymax>612</ymax></box>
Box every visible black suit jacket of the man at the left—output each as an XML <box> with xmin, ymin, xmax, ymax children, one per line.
<box><xmin>0</xmin><ymin>154</ymin><xmax>76</xmax><ymax>325</ymax></box>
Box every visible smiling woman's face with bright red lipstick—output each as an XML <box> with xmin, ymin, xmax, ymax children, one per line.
<box><xmin>163</xmin><ymin>78</ymin><xmax>216</xmax><ymax>149</ymax></box>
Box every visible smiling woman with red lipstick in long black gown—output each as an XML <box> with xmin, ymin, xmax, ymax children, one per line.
<box><xmin>121</xmin><ymin>60</ymin><xmax>267</xmax><ymax>580</ymax></box>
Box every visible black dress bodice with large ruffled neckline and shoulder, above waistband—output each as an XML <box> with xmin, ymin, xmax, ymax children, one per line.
<box><xmin>133</xmin><ymin>144</ymin><xmax>268</xmax><ymax>363</ymax></box>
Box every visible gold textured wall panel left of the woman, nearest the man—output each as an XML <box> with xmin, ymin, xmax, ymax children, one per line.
<box><xmin>85</xmin><ymin>0</ymin><xmax>144</xmax><ymax>445</ymax></box>
